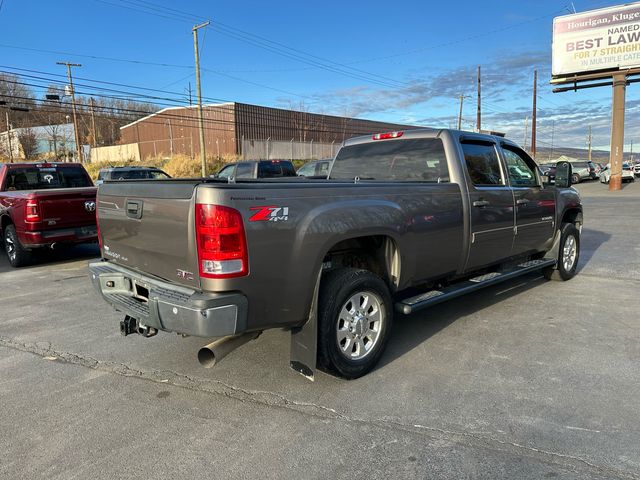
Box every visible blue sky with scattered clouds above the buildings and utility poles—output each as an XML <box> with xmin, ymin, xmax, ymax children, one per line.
<box><xmin>0</xmin><ymin>0</ymin><xmax>640</xmax><ymax>151</ymax></box>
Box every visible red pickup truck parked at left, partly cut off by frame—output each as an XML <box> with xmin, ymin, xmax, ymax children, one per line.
<box><xmin>0</xmin><ymin>163</ymin><xmax>97</xmax><ymax>267</ymax></box>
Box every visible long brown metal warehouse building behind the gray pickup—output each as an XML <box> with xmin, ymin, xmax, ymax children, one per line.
<box><xmin>120</xmin><ymin>102</ymin><xmax>415</xmax><ymax>159</ymax></box>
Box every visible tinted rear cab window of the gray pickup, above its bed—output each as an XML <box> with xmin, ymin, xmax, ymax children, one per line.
<box><xmin>330</xmin><ymin>138</ymin><xmax>449</xmax><ymax>183</ymax></box>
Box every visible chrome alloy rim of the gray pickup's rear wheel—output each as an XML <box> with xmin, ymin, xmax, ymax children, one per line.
<box><xmin>336</xmin><ymin>292</ymin><xmax>386</xmax><ymax>360</ymax></box>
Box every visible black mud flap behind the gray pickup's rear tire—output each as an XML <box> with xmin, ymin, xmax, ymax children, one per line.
<box><xmin>289</xmin><ymin>271</ymin><xmax>322</xmax><ymax>381</ymax></box>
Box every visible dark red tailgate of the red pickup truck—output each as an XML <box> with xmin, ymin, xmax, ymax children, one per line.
<box><xmin>33</xmin><ymin>187</ymin><xmax>96</xmax><ymax>230</ymax></box>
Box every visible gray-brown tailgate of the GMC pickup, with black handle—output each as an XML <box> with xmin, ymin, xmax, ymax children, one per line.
<box><xmin>98</xmin><ymin>180</ymin><xmax>200</xmax><ymax>288</ymax></box>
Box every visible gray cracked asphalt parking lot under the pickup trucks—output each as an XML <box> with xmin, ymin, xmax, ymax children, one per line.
<box><xmin>0</xmin><ymin>178</ymin><xmax>640</xmax><ymax>479</ymax></box>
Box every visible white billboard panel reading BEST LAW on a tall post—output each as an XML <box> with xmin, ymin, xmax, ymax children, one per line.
<box><xmin>552</xmin><ymin>2</ymin><xmax>640</xmax><ymax>77</ymax></box>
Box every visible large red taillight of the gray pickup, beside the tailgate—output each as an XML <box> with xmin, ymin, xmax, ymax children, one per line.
<box><xmin>196</xmin><ymin>203</ymin><xmax>249</xmax><ymax>278</ymax></box>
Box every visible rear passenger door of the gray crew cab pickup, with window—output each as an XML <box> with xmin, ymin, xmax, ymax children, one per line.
<box><xmin>462</xmin><ymin>140</ymin><xmax>515</xmax><ymax>271</ymax></box>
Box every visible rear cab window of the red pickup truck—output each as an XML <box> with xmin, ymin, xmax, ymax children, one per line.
<box><xmin>4</xmin><ymin>164</ymin><xmax>93</xmax><ymax>190</ymax></box>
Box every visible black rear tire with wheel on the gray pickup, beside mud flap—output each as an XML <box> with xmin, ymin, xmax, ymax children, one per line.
<box><xmin>318</xmin><ymin>268</ymin><xmax>393</xmax><ymax>379</ymax></box>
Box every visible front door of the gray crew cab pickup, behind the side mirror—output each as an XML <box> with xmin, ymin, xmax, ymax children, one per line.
<box><xmin>502</xmin><ymin>144</ymin><xmax>556</xmax><ymax>255</ymax></box>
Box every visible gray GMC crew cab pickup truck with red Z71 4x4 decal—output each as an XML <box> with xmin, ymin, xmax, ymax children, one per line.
<box><xmin>89</xmin><ymin>129</ymin><xmax>583</xmax><ymax>378</ymax></box>
